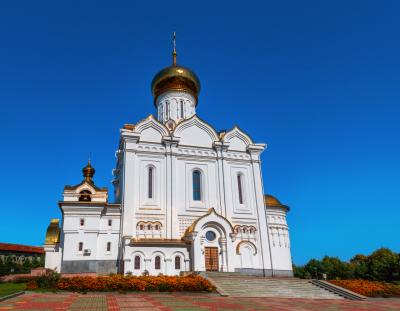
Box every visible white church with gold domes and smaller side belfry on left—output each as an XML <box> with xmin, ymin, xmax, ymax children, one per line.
<box><xmin>44</xmin><ymin>42</ymin><xmax>293</xmax><ymax>276</ymax></box>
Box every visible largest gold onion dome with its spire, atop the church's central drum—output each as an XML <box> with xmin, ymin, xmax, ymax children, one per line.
<box><xmin>151</xmin><ymin>34</ymin><xmax>200</xmax><ymax>105</ymax></box>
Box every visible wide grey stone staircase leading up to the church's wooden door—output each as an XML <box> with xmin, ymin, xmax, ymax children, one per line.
<box><xmin>203</xmin><ymin>272</ymin><xmax>343</xmax><ymax>299</ymax></box>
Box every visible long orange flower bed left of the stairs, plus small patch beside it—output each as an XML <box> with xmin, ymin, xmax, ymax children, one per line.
<box><xmin>27</xmin><ymin>274</ymin><xmax>215</xmax><ymax>292</ymax></box>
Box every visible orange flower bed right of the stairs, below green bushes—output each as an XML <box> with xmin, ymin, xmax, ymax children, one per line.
<box><xmin>329</xmin><ymin>280</ymin><xmax>400</xmax><ymax>297</ymax></box>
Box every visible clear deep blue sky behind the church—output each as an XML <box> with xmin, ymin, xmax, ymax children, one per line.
<box><xmin>0</xmin><ymin>1</ymin><xmax>400</xmax><ymax>264</ymax></box>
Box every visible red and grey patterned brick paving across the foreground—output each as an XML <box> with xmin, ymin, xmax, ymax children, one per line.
<box><xmin>0</xmin><ymin>293</ymin><xmax>400</xmax><ymax>311</ymax></box>
